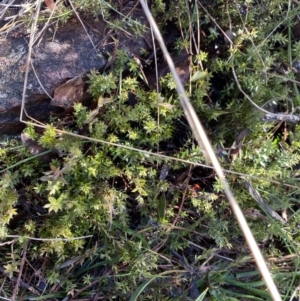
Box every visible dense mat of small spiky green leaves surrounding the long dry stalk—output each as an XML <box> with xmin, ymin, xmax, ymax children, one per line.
<box><xmin>0</xmin><ymin>0</ymin><xmax>300</xmax><ymax>300</ymax></box>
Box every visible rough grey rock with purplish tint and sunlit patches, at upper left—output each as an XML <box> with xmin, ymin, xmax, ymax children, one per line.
<box><xmin>0</xmin><ymin>14</ymin><xmax>107</xmax><ymax>135</ymax></box>
